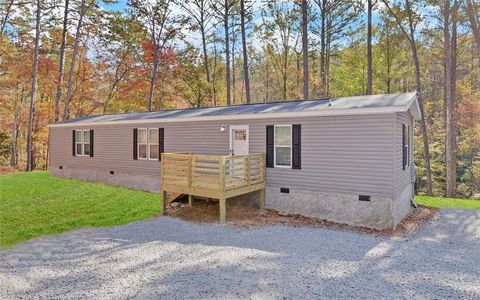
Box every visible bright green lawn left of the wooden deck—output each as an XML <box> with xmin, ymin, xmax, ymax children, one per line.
<box><xmin>0</xmin><ymin>172</ymin><xmax>160</xmax><ymax>246</ymax></box>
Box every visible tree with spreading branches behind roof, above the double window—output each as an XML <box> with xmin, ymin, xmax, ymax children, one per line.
<box><xmin>128</xmin><ymin>0</ymin><xmax>178</xmax><ymax>111</ymax></box>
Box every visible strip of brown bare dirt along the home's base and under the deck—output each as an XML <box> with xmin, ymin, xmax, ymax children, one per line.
<box><xmin>167</xmin><ymin>200</ymin><xmax>438</xmax><ymax>236</ymax></box>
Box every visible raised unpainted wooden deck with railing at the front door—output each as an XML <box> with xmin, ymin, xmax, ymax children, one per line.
<box><xmin>161</xmin><ymin>153</ymin><xmax>265</xmax><ymax>222</ymax></box>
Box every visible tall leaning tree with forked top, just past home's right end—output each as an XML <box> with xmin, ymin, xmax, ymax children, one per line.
<box><xmin>382</xmin><ymin>0</ymin><xmax>433</xmax><ymax>196</ymax></box>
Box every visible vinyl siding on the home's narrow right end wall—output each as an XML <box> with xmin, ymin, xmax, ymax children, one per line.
<box><xmin>393</xmin><ymin>112</ymin><xmax>413</xmax><ymax>196</ymax></box>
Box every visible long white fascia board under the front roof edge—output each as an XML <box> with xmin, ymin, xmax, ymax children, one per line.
<box><xmin>47</xmin><ymin>105</ymin><xmax>410</xmax><ymax>128</ymax></box>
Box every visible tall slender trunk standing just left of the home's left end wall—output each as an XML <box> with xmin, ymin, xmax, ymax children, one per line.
<box><xmin>25</xmin><ymin>0</ymin><xmax>41</xmax><ymax>172</ymax></box>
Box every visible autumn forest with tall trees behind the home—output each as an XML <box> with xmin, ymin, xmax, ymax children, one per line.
<box><xmin>0</xmin><ymin>0</ymin><xmax>480</xmax><ymax>198</ymax></box>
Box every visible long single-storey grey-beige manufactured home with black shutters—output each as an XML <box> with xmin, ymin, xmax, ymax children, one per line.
<box><xmin>49</xmin><ymin>93</ymin><xmax>420</xmax><ymax>229</ymax></box>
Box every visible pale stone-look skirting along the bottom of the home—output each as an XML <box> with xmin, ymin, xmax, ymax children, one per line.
<box><xmin>50</xmin><ymin>167</ymin><xmax>412</xmax><ymax>229</ymax></box>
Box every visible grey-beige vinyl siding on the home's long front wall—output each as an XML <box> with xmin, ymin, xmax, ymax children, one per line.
<box><xmin>50</xmin><ymin>113</ymin><xmax>394</xmax><ymax>196</ymax></box>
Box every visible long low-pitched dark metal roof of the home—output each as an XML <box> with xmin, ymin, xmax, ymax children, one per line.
<box><xmin>57</xmin><ymin>93</ymin><xmax>415</xmax><ymax>124</ymax></box>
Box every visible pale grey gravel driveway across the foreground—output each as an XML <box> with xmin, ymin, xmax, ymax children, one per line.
<box><xmin>0</xmin><ymin>210</ymin><xmax>480</xmax><ymax>299</ymax></box>
